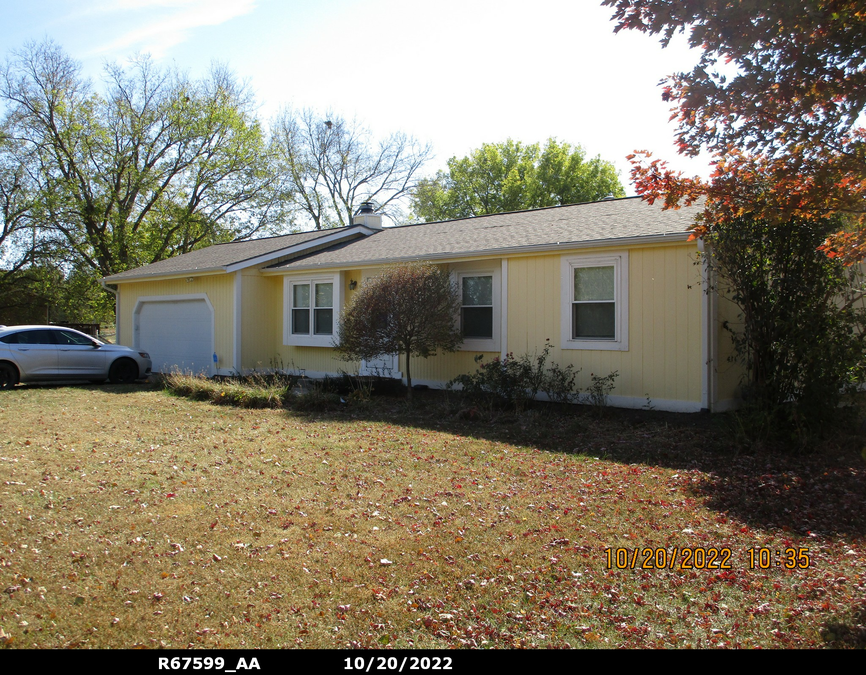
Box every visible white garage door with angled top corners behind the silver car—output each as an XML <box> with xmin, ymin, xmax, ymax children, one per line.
<box><xmin>135</xmin><ymin>300</ymin><xmax>213</xmax><ymax>375</ymax></box>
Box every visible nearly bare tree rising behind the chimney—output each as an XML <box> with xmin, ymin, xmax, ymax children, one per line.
<box><xmin>271</xmin><ymin>110</ymin><xmax>431</xmax><ymax>230</ymax></box>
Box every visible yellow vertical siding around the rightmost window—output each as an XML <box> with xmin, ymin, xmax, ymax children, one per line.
<box><xmin>508</xmin><ymin>244</ymin><xmax>703</xmax><ymax>410</ymax></box>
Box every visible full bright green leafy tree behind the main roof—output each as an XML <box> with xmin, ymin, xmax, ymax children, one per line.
<box><xmin>412</xmin><ymin>138</ymin><xmax>625</xmax><ymax>222</ymax></box>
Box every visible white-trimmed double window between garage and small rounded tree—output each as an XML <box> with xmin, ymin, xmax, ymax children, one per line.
<box><xmin>283</xmin><ymin>275</ymin><xmax>340</xmax><ymax>347</ymax></box>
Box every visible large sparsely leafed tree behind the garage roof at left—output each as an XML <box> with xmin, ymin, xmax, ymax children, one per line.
<box><xmin>0</xmin><ymin>42</ymin><xmax>276</xmax><ymax>276</ymax></box>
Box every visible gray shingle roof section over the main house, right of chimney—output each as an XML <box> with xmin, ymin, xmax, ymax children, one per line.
<box><xmin>269</xmin><ymin>197</ymin><xmax>700</xmax><ymax>269</ymax></box>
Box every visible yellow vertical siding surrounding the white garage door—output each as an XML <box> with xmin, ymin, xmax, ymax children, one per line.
<box><xmin>118</xmin><ymin>274</ymin><xmax>234</xmax><ymax>368</ymax></box>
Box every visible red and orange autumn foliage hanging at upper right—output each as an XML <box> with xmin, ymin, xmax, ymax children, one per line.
<box><xmin>603</xmin><ymin>0</ymin><xmax>866</xmax><ymax>264</ymax></box>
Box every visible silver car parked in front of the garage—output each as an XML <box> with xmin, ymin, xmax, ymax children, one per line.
<box><xmin>0</xmin><ymin>326</ymin><xmax>152</xmax><ymax>389</ymax></box>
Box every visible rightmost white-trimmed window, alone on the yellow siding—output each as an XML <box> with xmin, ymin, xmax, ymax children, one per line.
<box><xmin>561</xmin><ymin>252</ymin><xmax>628</xmax><ymax>351</ymax></box>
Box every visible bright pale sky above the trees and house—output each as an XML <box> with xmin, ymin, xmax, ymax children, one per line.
<box><xmin>0</xmin><ymin>0</ymin><xmax>709</xmax><ymax>194</ymax></box>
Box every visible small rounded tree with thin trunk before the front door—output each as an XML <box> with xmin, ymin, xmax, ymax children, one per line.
<box><xmin>337</xmin><ymin>262</ymin><xmax>463</xmax><ymax>401</ymax></box>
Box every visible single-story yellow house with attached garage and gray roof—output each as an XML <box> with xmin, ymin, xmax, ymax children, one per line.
<box><xmin>105</xmin><ymin>198</ymin><xmax>739</xmax><ymax>412</ymax></box>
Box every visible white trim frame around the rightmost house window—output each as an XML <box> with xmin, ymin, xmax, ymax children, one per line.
<box><xmin>560</xmin><ymin>251</ymin><xmax>628</xmax><ymax>351</ymax></box>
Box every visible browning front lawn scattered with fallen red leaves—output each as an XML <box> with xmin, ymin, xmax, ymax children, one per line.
<box><xmin>0</xmin><ymin>386</ymin><xmax>866</xmax><ymax>648</ymax></box>
